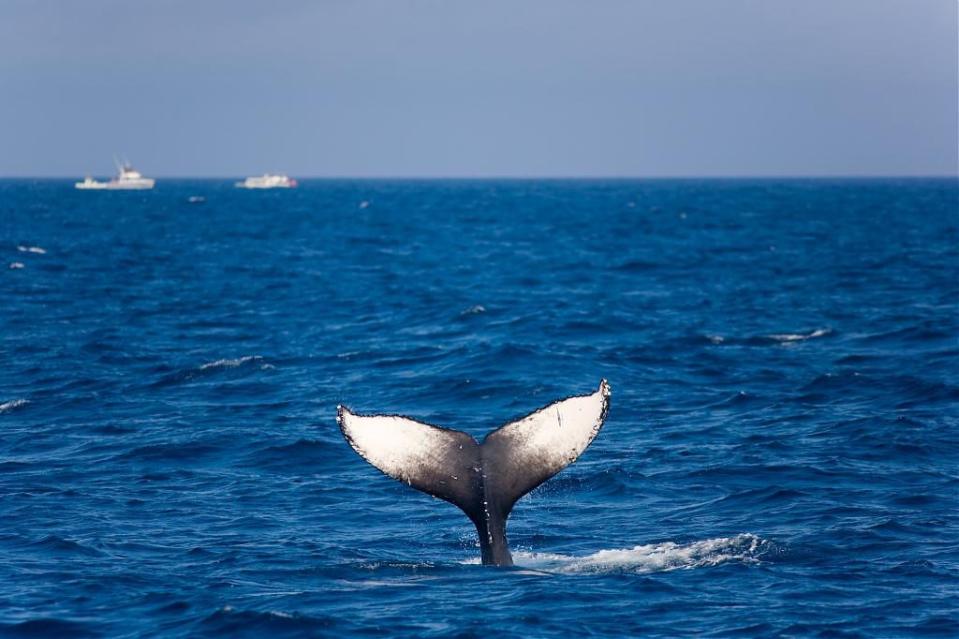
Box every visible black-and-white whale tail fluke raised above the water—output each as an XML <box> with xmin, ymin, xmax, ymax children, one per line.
<box><xmin>336</xmin><ymin>379</ymin><xmax>611</xmax><ymax>566</ymax></box>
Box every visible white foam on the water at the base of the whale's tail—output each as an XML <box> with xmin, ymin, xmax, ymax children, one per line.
<box><xmin>466</xmin><ymin>533</ymin><xmax>769</xmax><ymax>574</ymax></box>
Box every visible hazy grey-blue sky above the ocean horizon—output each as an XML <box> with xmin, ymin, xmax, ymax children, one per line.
<box><xmin>0</xmin><ymin>0</ymin><xmax>959</xmax><ymax>177</ymax></box>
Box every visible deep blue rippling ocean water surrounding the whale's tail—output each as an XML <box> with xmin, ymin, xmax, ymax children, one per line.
<box><xmin>0</xmin><ymin>179</ymin><xmax>959</xmax><ymax>637</ymax></box>
